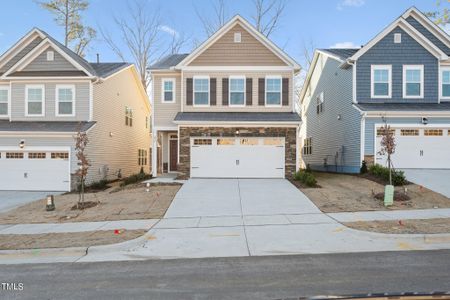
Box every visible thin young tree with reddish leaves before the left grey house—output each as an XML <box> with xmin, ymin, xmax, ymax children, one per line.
<box><xmin>75</xmin><ymin>124</ymin><xmax>91</xmax><ymax>209</ymax></box>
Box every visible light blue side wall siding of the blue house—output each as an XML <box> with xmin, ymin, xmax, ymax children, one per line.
<box><xmin>300</xmin><ymin>54</ymin><xmax>361</xmax><ymax>173</ymax></box>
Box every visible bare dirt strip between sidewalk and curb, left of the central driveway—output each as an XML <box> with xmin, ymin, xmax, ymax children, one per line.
<box><xmin>0</xmin><ymin>230</ymin><xmax>147</xmax><ymax>250</ymax></box>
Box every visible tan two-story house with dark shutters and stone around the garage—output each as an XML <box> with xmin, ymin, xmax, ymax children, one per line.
<box><xmin>150</xmin><ymin>16</ymin><xmax>300</xmax><ymax>178</ymax></box>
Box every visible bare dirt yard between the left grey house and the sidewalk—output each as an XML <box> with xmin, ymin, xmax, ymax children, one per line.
<box><xmin>0</xmin><ymin>184</ymin><xmax>181</xmax><ymax>224</ymax></box>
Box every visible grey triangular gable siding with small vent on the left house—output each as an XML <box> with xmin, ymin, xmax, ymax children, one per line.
<box><xmin>22</xmin><ymin>47</ymin><xmax>78</xmax><ymax>71</ymax></box>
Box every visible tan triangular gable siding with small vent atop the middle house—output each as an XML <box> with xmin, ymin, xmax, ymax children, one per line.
<box><xmin>189</xmin><ymin>24</ymin><xmax>286</xmax><ymax>66</ymax></box>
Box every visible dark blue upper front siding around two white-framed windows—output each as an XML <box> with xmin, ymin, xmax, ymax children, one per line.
<box><xmin>356</xmin><ymin>27</ymin><xmax>439</xmax><ymax>103</ymax></box>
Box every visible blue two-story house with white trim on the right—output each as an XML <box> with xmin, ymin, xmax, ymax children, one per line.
<box><xmin>300</xmin><ymin>7</ymin><xmax>450</xmax><ymax>173</ymax></box>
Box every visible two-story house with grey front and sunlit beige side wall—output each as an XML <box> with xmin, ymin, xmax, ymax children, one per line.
<box><xmin>0</xmin><ymin>29</ymin><xmax>151</xmax><ymax>191</ymax></box>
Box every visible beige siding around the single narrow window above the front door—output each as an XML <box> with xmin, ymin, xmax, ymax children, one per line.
<box><xmin>153</xmin><ymin>73</ymin><xmax>181</xmax><ymax>127</ymax></box>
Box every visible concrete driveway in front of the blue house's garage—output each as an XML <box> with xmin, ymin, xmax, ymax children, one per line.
<box><xmin>402</xmin><ymin>169</ymin><xmax>450</xmax><ymax>198</ymax></box>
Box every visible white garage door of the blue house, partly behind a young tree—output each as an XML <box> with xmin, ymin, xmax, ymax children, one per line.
<box><xmin>375</xmin><ymin>126</ymin><xmax>450</xmax><ymax>169</ymax></box>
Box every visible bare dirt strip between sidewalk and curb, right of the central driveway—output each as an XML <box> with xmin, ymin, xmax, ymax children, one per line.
<box><xmin>343</xmin><ymin>218</ymin><xmax>450</xmax><ymax>234</ymax></box>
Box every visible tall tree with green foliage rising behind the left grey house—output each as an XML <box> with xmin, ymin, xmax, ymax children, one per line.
<box><xmin>36</xmin><ymin>0</ymin><xmax>96</xmax><ymax>56</ymax></box>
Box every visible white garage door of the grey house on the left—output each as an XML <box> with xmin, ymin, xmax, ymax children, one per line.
<box><xmin>0</xmin><ymin>149</ymin><xmax>70</xmax><ymax>191</ymax></box>
